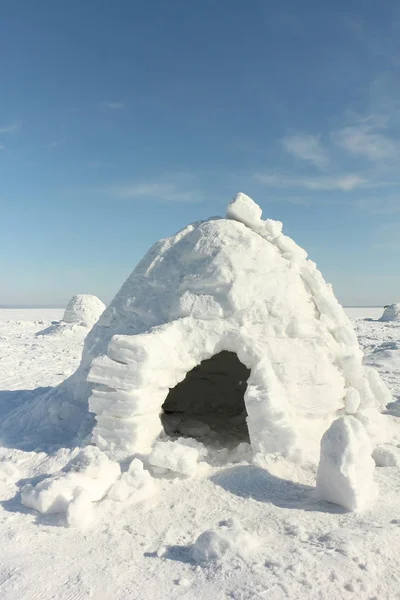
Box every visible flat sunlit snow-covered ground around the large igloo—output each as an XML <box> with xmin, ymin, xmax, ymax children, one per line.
<box><xmin>0</xmin><ymin>308</ymin><xmax>400</xmax><ymax>600</ymax></box>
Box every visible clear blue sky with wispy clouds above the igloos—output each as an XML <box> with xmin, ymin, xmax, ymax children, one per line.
<box><xmin>0</xmin><ymin>0</ymin><xmax>400</xmax><ymax>305</ymax></box>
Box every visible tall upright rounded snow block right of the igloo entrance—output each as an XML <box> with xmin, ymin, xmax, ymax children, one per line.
<box><xmin>316</xmin><ymin>416</ymin><xmax>377</xmax><ymax>511</ymax></box>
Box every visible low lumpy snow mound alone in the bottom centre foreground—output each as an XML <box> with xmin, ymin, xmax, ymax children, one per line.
<box><xmin>192</xmin><ymin>519</ymin><xmax>260</xmax><ymax>564</ymax></box>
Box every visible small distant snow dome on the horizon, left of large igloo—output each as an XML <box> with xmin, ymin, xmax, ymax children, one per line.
<box><xmin>37</xmin><ymin>294</ymin><xmax>106</xmax><ymax>335</ymax></box>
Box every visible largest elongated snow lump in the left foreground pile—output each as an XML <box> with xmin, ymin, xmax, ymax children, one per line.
<box><xmin>21</xmin><ymin>446</ymin><xmax>121</xmax><ymax>520</ymax></box>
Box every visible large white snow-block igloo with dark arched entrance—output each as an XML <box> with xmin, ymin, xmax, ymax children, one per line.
<box><xmin>70</xmin><ymin>194</ymin><xmax>391</xmax><ymax>461</ymax></box>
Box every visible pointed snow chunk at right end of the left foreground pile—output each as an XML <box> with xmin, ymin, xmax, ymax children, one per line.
<box><xmin>107</xmin><ymin>458</ymin><xmax>156</xmax><ymax>504</ymax></box>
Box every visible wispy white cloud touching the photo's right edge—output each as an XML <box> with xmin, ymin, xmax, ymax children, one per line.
<box><xmin>333</xmin><ymin>123</ymin><xmax>400</xmax><ymax>162</ymax></box>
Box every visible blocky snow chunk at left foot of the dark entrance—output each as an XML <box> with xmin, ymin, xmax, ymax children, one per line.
<box><xmin>149</xmin><ymin>441</ymin><xmax>199</xmax><ymax>476</ymax></box>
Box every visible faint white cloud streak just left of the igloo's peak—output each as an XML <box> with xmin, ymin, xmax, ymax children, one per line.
<box><xmin>107</xmin><ymin>180</ymin><xmax>203</xmax><ymax>203</ymax></box>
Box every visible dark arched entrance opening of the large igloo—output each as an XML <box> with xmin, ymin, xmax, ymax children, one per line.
<box><xmin>161</xmin><ymin>351</ymin><xmax>250</xmax><ymax>447</ymax></box>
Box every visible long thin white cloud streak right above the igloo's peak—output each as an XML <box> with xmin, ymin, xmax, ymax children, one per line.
<box><xmin>254</xmin><ymin>173</ymin><xmax>371</xmax><ymax>192</ymax></box>
